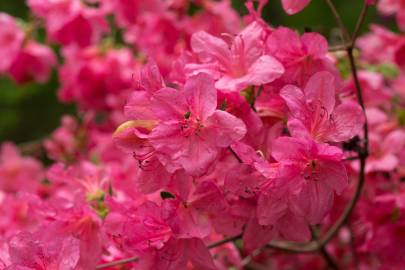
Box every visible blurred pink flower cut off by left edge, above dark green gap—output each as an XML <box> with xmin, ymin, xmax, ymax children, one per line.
<box><xmin>0</xmin><ymin>12</ymin><xmax>24</xmax><ymax>73</ymax></box>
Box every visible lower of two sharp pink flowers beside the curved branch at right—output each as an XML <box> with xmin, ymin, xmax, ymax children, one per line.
<box><xmin>272</xmin><ymin>137</ymin><xmax>348</xmax><ymax>224</ymax></box>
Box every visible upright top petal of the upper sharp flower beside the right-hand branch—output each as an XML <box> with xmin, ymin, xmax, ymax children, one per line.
<box><xmin>304</xmin><ymin>71</ymin><xmax>335</xmax><ymax>114</ymax></box>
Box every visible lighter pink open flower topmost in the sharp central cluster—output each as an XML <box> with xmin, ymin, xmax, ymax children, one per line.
<box><xmin>186</xmin><ymin>22</ymin><xmax>284</xmax><ymax>91</ymax></box>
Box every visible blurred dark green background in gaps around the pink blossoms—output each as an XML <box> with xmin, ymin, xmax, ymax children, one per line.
<box><xmin>0</xmin><ymin>0</ymin><xmax>395</xmax><ymax>143</ymax></box>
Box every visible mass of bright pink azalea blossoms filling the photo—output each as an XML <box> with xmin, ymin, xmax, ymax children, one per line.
<box><xmin>0</xmin><ymin>0</ymin><xmax>405</xmax><ymax>270</ymax></box>
